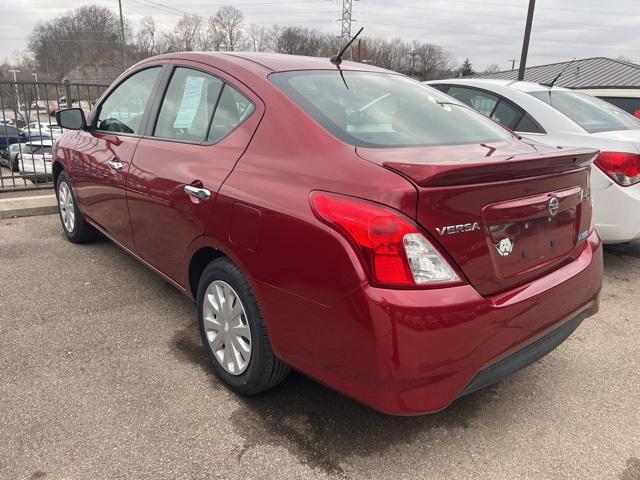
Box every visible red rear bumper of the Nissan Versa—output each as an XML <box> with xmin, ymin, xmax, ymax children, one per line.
<box><xmin>259</xmin><ymin>232</ymin><xmax>603</xmax><ymax>415</ymax></box>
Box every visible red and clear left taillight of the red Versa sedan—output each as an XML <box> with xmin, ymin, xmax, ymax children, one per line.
<box><xmin>311</xmin><ymin>192</ymin><xmax>460</xmax><ymax>287</ymax></box>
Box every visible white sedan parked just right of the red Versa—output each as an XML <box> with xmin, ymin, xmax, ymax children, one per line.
<box><xmin>426</xmin><ymin>79</ymin><xmax>640</xmax><ymax>243</ymax></box>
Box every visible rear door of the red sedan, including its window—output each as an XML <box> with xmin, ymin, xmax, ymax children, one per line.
<box><xmin>127</xmin><ymin>62</ymin><xmax>264</xmax><ymax>285</ymax></box>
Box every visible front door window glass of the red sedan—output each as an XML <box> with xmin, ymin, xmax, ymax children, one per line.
<box><xmin>96</xmin><ymin>67</ymin><xmax>161</xmax><ymax>134</ymax></box>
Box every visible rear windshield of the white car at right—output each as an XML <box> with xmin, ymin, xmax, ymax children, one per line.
<box><xmin>531</xmin><ymin>90</ymin><xmax>640</xmax><ymax>133</ymax></box>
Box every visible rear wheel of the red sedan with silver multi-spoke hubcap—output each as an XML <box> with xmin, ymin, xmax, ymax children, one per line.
<box><xmin>197</xmin><ymin>257</ymin><xmax>289</xmax><ymax>395</ymax></box>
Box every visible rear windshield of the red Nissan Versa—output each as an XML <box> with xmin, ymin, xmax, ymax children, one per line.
<box><xmin>269</xmin><ymin>69</ymin><xmax>511</xmax><ymax>147</ymax></box>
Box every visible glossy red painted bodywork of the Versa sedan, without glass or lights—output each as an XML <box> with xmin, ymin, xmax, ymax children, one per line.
<box><xmin>56</xmin><ymin>53</ymin><xmax>602</xmax><ymax>414</ymax></box>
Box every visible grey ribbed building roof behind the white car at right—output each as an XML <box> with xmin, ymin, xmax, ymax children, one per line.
<box><xmin>474</xmin><ymin>57</ymin><xmax>640</xmax><ymax>88</ymax></box>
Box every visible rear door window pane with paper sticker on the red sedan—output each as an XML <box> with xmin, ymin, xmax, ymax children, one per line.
<box><xmin>153</xmin><ymin>67</ymin><xmax>224</xmax><ymax>142</ymax></box>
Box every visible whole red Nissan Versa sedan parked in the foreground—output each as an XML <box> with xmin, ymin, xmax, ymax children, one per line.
<box><xmin>53</xmin><ymin>53</ymin><xmax>602</xmax><ymax>414</ymax></box>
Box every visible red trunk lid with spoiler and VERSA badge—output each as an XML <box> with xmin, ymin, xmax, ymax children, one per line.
<box><xmin>357</xmin><ymin>141</ymin><xmax>597</xmax><ymax>295</ymax></box>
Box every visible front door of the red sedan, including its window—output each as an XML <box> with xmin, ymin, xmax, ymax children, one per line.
<box><xmin>71</xmin><ymin>65</ymin><xmax>162</xmax><ymax>248</ymax></box>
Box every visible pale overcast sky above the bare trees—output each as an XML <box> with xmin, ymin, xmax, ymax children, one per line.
<box><xmin>0</xmin><ymin>0</ymin><xmax>640</xmax><ymax>71</ymax></box>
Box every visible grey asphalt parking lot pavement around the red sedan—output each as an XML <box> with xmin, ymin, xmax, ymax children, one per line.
<box><xmin>0</xmin><ymin>215</ymin><xmax>640</xmax><ymax>480</ymax></box>
